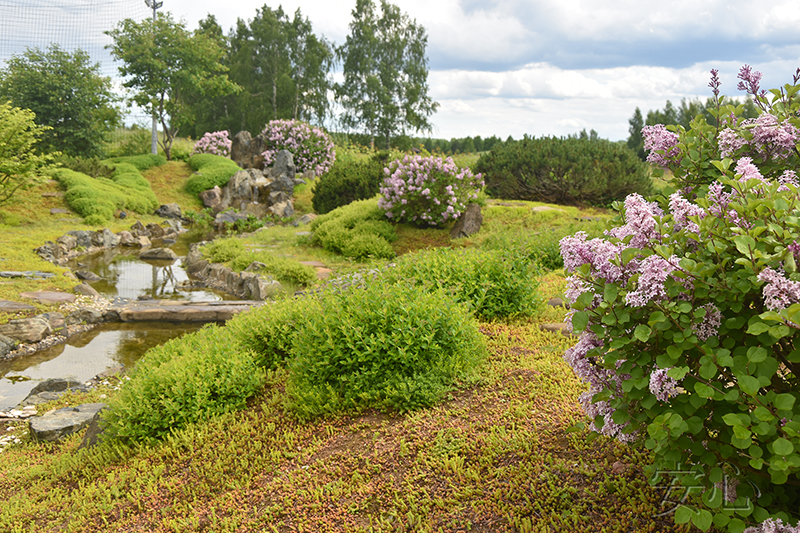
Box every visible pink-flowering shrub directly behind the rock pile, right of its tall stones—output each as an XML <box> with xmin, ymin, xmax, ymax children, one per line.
<box><xmin>261</xmin><ymin>120</ymin><xmax>336</xmax><ymax>176</ymax></box>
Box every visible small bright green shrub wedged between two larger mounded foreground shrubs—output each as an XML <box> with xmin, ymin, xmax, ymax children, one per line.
<box><xmin>225</xmin><ymin>295</ymin><xmax>320</xmax><ymax>369</ymax></box>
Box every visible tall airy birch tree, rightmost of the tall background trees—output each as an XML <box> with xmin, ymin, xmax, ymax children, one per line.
<box><xmin>336</xmin><ymin>0</ymin><xmax>439</xmax><ymax>148</ymax></box>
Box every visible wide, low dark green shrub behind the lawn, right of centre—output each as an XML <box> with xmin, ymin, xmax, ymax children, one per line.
<box><xmin>475</xmin><ymin>137</ymin><xmax>652</xmax><ymax>206</ymax></box>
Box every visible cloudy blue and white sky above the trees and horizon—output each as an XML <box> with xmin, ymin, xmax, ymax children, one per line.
<box><xmin>0</xmin><ymin>0</ymin><xmax>800</xmax><ymax>140</ymax></box>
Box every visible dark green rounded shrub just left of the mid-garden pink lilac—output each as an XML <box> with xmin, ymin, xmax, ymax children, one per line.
<box><xmin>312</xmin><ymin>151</ymin><xmax>389</xmax><ymax>214</ymax></box>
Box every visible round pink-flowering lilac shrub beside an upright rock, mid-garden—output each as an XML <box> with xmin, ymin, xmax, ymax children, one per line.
<box><xmin>378</xmin><ymin>155</ymin><xmax>483</xmax><ymax>226</ymax></box>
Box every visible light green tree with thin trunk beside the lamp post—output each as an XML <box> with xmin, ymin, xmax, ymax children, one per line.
<box><xmin>106</xmin><ymin>13</ymin><xmax>240</xmax><ymax>159</ymax></box>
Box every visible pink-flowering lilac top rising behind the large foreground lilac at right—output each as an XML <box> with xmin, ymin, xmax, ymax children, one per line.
<box><xmin>642</xmin><ymin>65</ymin><xmax>800</xmax><ymax>186</ymax></box>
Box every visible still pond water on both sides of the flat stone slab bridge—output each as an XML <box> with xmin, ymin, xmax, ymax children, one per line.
<box><xmin>0</xmin><ymin>234</ymin><xmax>237</xmax><ymax>410</ymax></box>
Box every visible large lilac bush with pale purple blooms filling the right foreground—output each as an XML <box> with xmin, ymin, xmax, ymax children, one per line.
<box><xmin>561</xmin><ymin>66</ymin><xmax>800</xmax><ymax>533</ymax></box>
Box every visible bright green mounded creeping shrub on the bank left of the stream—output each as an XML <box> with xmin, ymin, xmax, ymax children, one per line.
<box><xmin>53</xmin><ymin>156</ymin><xmax>158</xmax><ymax>225</ymax></box>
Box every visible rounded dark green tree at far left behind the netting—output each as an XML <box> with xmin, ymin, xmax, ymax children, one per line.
<box><xmin>0</xmin><ymin>44</ymin><xmax>122</xmax><ymax>157</ymax></box>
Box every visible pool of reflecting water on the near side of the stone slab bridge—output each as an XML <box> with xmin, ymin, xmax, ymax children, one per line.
<box><xmin>0</xmin><ymin>322</ymin><xmax>209</xmax><ymax>410</ymax></box>
